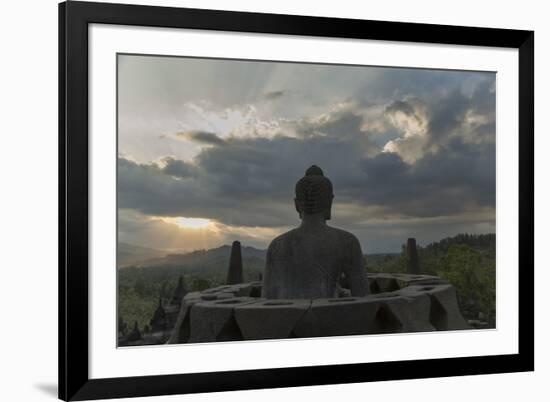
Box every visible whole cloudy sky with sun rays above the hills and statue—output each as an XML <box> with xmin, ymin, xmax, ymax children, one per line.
<box><xmin>118</xmin><ymin>55</ymin><xmax>495</xmax><ymax>253</ymax></box>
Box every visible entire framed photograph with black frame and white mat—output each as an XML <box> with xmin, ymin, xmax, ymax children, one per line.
<box><xmin>59</xmin><ymin>1</ymin><xmax>534</xmax><ymax>400</ymax></box>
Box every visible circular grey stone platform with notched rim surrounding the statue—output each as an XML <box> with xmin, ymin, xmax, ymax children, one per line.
<box><xmin>167</xmin><ymin>273</ymin><xmax>469</xmax><ymax>344</ymax></box>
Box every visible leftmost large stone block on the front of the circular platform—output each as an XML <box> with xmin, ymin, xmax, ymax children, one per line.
<box><xmin>189</xmin><ymin>297</ymin><xmax>255</xmax><ymax>342</ymax></box>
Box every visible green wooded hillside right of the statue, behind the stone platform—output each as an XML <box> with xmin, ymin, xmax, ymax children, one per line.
<box><xmin>366</xmin><ymin>233</ymin><xmax>496</xmax><ymax>326</ymax></box>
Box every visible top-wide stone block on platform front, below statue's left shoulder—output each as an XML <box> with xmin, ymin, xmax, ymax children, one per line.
<box><xmin>235</xmin><ymin>299</ymin><xmax>311</xmax><ymax>340</ymax></box>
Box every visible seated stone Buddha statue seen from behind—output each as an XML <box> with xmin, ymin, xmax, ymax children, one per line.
<box><xmin>262</xmin><ymin>165</ymin><xmax>368</xmax><ymax>299</ymax></box>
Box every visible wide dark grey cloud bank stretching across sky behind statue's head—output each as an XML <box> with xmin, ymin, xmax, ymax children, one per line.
<box><xmin>119</xmin><ymin>77</ymin><xmax>495</xmax><ymax>237</ymax></box>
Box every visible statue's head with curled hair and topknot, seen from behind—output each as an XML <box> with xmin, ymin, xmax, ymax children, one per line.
<box><xmin>294</xmin><ymin>165</ymin><xmax>334</xmax><ymax>220</ymax></box>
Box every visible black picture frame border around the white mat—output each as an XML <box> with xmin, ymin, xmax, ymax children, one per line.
<box><xmin>59</xmin><ymin>1</ymin><xmax>534</xmax><ymax>400</ymax></box>
